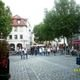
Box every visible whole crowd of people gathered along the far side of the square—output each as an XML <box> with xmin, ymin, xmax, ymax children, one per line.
<box><xmin>13</xmin><ymin>46</ymin><xmax>80</xmax><ymax>59</ymax></box>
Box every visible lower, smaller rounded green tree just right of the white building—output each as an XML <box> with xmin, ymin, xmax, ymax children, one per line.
<box><xmin>34</xmin><ymin>23</ymin><xmax>54</xmax><ymax>41</ymax></box>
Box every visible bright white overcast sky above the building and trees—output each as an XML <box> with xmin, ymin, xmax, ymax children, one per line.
<box><xmin>2</xmin><ymin>0</ymin><xmax>80</xmax><ymax>27</ymax></box>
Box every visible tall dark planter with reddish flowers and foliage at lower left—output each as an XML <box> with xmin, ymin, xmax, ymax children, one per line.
<box><xmin>0</xmin><ymin>39</ymin><xmax>9</xmax><ymax>80</ymax></box>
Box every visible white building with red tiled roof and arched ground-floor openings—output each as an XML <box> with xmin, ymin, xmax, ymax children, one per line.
<box><xmin>7</xmin><ymin>15</ymin><xmax>31</xmax><ymax>51</ymax></box>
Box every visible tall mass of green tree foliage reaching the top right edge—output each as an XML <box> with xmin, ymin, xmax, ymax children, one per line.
<box><xmin>33</xmin><ymin>0</ymin><xmax>80</xmax><ymax>40</ymax></box>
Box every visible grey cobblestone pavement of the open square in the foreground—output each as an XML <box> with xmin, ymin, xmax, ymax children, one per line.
<box><xmin>10</xmin><ymin>56</ymin><xmax>80</xmax><ymax>80</ymax></box>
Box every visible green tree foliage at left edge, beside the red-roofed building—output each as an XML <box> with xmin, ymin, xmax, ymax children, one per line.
<box><xmin>0</xmin><ymin>0</ymin><xmax>12</xmax><ymax>38</ymax></box>
